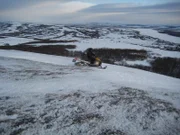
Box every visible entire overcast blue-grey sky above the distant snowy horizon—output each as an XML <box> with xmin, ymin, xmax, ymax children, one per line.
<box><xmin>0</xmin><ymin>0</ymin><xmax>180</xmax><ymax>25</ymax></box>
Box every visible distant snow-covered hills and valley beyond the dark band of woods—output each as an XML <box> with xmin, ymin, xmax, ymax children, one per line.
<box><xmin>0</xmin><ymin>22</ymin><xmax>180</xmax><ymax>58</ymax></box>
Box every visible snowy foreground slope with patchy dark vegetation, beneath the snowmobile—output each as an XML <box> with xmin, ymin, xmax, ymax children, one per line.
<box><xmin>0</xmin><ymin>50</ymin><xmax>180</xmax><ymax>135</ymax></box>
